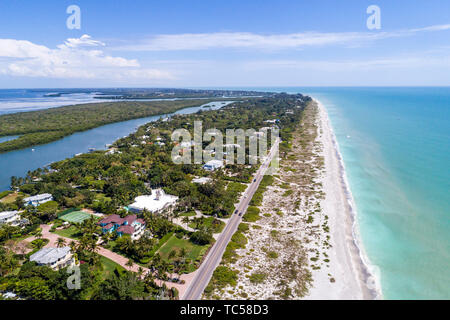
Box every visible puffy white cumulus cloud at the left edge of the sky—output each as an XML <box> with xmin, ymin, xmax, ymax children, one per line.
<box><xmin>0</xmin><ymin>35</ymin><xmax>173</xmax><ymax>80</ymax></box>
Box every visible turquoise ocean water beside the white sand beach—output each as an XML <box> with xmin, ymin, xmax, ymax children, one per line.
<box><xmin>298</xmin><ymin>88</ymin><xmax>450</xmax><ymax>299</ymax></box>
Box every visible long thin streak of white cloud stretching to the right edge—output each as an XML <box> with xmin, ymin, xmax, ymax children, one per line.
<box><xmin>115</xmin><ymin>25</ymin><xmax>450</xmax><ymax>51</ymax></box>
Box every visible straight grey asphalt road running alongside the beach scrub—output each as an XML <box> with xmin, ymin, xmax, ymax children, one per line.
<box><xmin>182</xmin><ymin>139</ymin><xmax>280</xmax><ymax>300</ymax></box>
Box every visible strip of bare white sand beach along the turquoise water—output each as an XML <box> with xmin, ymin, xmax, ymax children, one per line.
<box><xmin>306</xmin><ymin>98</ymin><xmax>382</xmax><ymax>300</ymax></box>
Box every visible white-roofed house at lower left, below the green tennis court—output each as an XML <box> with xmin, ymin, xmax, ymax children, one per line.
<box><xmin>30</xmin><ymin>247</ymin><xmax>75</xmax><ymax>270</ymax></box>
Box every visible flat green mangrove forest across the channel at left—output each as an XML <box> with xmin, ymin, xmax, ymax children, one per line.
<box><xmin>0</xmin><ymin>99</ymin><xmax>221</xmax><ymax>153</ymax></box>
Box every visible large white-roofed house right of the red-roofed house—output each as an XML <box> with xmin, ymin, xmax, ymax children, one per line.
<box><xmin>128</xmin><ymin>189</ymin><xmax>178</xmax><ymax>213</ymax></box>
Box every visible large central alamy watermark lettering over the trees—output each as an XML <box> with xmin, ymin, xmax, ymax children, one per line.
<box><xmin>171</xmin><ymin>120</ymin><xmax>280</xmax><ymax>174</ymax></box>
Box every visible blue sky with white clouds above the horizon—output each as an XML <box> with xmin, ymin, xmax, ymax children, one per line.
<box><xmin>0</xmin><ymin>0</ymin><xmax>450</xmax><ymax>88</ymax></box>
